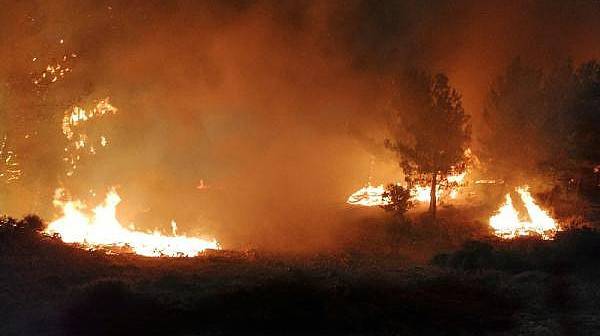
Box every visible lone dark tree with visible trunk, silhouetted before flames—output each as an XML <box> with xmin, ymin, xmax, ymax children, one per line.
<box><xmin>386</xmin><ymin>71</ymin><xmax>471</xmax><ymax>218</ymax></box>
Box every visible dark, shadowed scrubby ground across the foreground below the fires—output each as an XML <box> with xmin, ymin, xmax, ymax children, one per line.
<box><xmin>0</xmin><ymin>217</ymin><xmax>600</xmax><ymax>336</ymax></box>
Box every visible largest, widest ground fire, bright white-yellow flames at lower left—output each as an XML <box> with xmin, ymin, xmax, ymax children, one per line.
<box><xmin>45</xmin><ymin>190</ymin><xmax>219</xmax><ymax>257</ymax></box>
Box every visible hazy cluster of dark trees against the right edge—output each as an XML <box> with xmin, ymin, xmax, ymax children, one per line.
<box><xmin>480</xmin><ymin>58</ymin><xmax>600</xmax><ymax>182</ymax></box>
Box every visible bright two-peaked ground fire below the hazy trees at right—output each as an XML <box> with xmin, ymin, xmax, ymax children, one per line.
<box><xmin>490</xmin><ymin>186</ymin><xmax>560</xmax><ymax>239</ymax></box>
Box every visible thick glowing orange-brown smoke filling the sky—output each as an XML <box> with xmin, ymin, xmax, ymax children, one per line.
<box><xmin>0</xmin><ymin>1</ymin><xmax>600</xmax><ymax>249</ymax></box>
